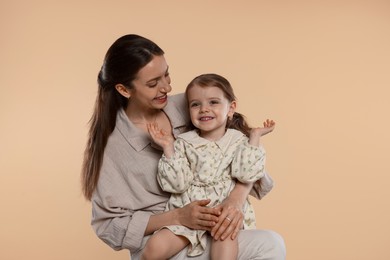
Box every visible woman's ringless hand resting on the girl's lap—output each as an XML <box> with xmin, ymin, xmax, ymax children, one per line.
<box><xmin>177</xmin><ymin>199</ymin><xmax>221</xmax><ymax>231</ymax></box>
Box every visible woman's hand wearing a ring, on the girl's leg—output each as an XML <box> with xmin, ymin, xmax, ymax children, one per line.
<box><xmin>211</xmin><ymin>197</ymin><xmax>244</xmax><ymax>240</ymax></box>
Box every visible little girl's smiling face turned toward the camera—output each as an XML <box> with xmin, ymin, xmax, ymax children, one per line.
<box><xmin>187</xmin><ymin>85</ymin><xmax>236</xmax><ymax>140</ymax></box>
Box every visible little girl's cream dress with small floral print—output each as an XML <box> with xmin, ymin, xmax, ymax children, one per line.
<box><xmin>157</xmin><ymin>129</ymin><xmax>265</xmax><ymax>256</ymax></box>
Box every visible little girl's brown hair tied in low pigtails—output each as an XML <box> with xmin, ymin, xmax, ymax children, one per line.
<box><xmin>186</xmin><ymin>73</ymin><xmax>252</xmax><ymax>137</ymax></box>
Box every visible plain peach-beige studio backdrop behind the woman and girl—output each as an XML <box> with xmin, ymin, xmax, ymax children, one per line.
<box><xmin>0</xmin><ymin>0</ymin><xmax>390</xmax><ymax>260</ymax></box>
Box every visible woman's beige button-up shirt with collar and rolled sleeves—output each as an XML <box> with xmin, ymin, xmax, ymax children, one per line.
<box><xmin>91</xmin><ymin>94</ymin><xmax>273</xmax><ymax>252</ymax></box>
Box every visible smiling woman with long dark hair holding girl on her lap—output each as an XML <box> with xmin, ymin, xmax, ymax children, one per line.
<box><xmin>82</xmin><ymin>35</ymin><xmax>285</xmax><ymax>260</ymax></box>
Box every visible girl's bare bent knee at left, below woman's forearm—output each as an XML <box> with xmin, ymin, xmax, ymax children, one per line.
<box><xmin>141</xmin><ymin>228</ymin><xmax>189</xmax><ymax>260</ymax></box>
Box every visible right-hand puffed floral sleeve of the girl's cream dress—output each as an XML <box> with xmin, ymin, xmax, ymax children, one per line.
<box><xmin>232</xmin><ymin>138</ymin><xmax>265</xmax><ymax>183</ymax></box>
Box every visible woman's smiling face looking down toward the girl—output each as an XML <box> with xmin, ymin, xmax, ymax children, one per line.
<box><xmin>129</xmin><ymin>55</ymin><xmax>172</xmax><ymax>110</ymax></box>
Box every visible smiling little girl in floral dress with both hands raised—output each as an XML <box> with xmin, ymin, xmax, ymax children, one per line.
<box><xmin>142</xmin><ymin>74</ymin><xmax>275</xmax><ymax>260</ymax></box>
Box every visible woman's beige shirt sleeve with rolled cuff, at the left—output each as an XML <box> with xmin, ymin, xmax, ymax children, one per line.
<box><xmin>91</xmin><ymin>155</ymin><xmax>152</xmax><ymax>252</ymax></box>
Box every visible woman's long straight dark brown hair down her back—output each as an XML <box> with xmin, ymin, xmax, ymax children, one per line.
<box><xmin>81</xmin><ymin>34</ymin><xmax>164</xmax><ymax>200</ymax></box>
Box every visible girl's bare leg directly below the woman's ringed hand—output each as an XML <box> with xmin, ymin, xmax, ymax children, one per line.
<box><xmin>211</xmin><ymin>238</ymin><xmax>238</xmax><ymax>260</ymax></box>
